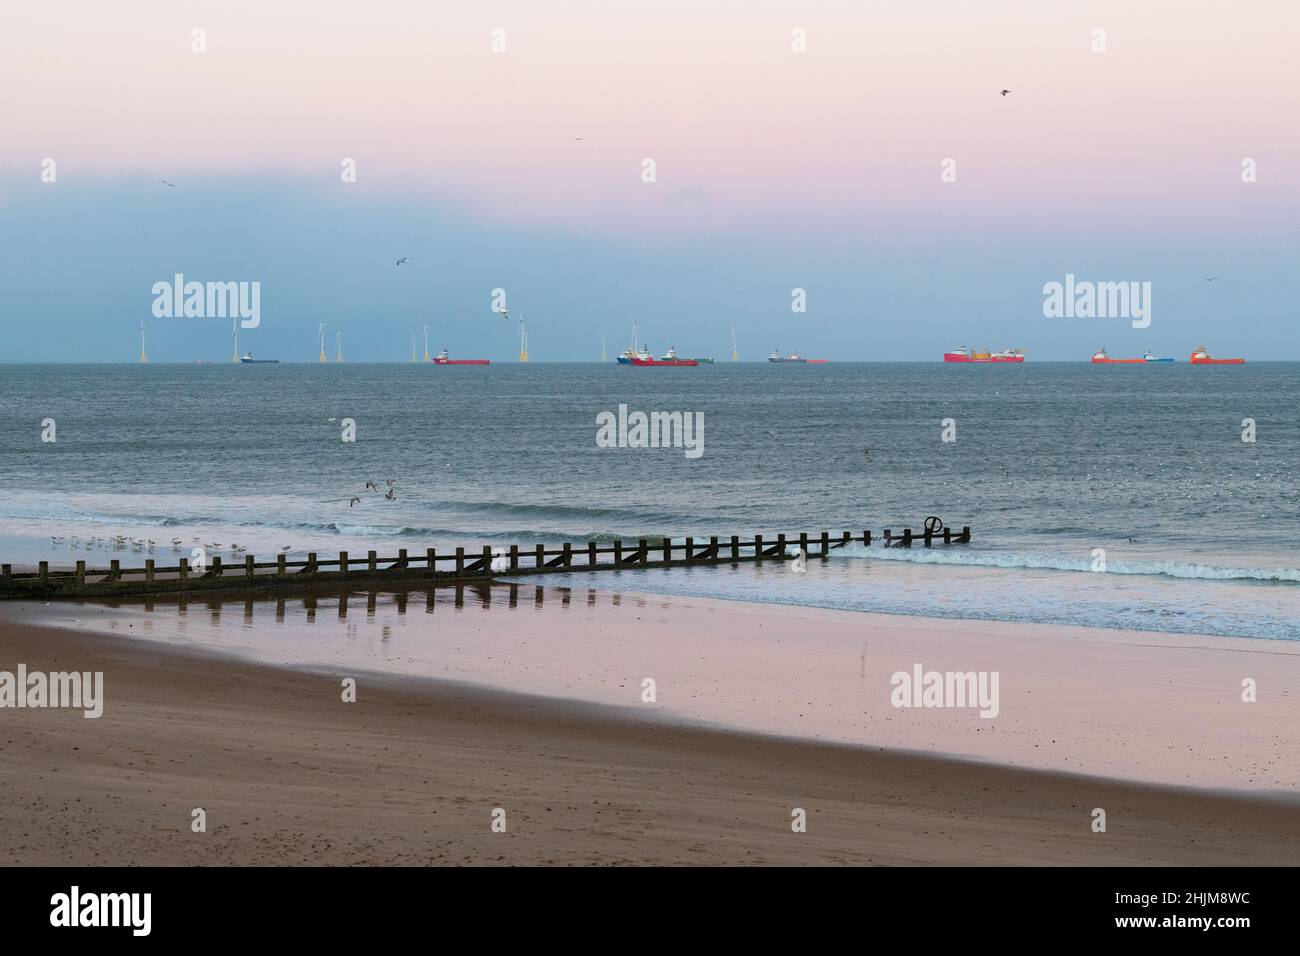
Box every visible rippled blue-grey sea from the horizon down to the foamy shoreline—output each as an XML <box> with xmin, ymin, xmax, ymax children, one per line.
<box><xmin>0</xmin><ymin>360</ymin><xmax>1300</xmax><ymax>640</ymax></box>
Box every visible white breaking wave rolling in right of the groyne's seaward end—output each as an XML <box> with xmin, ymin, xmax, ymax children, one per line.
<box><xmin>832</xmin><ymin>545</ymin><xmax>1300</xmax><ymax>584</ymax></box>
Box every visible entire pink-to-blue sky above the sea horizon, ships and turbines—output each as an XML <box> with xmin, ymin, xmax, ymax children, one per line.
<box><xmin>0</xmin><ymin>0</ymin><xmax>1300</xmax><ymax>363</ymax></box>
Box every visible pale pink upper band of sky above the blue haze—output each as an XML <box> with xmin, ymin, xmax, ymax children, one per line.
<box><xmin>0</xmin><ymin>0</ymin><xmax>1300</xmax><ymax>232</ymax></box>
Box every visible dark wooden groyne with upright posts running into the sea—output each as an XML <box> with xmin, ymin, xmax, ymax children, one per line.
<box><xmin>0</xmin><ymin>519</ymin><xmax>971</xmax><ymax>601</ymax></box>
